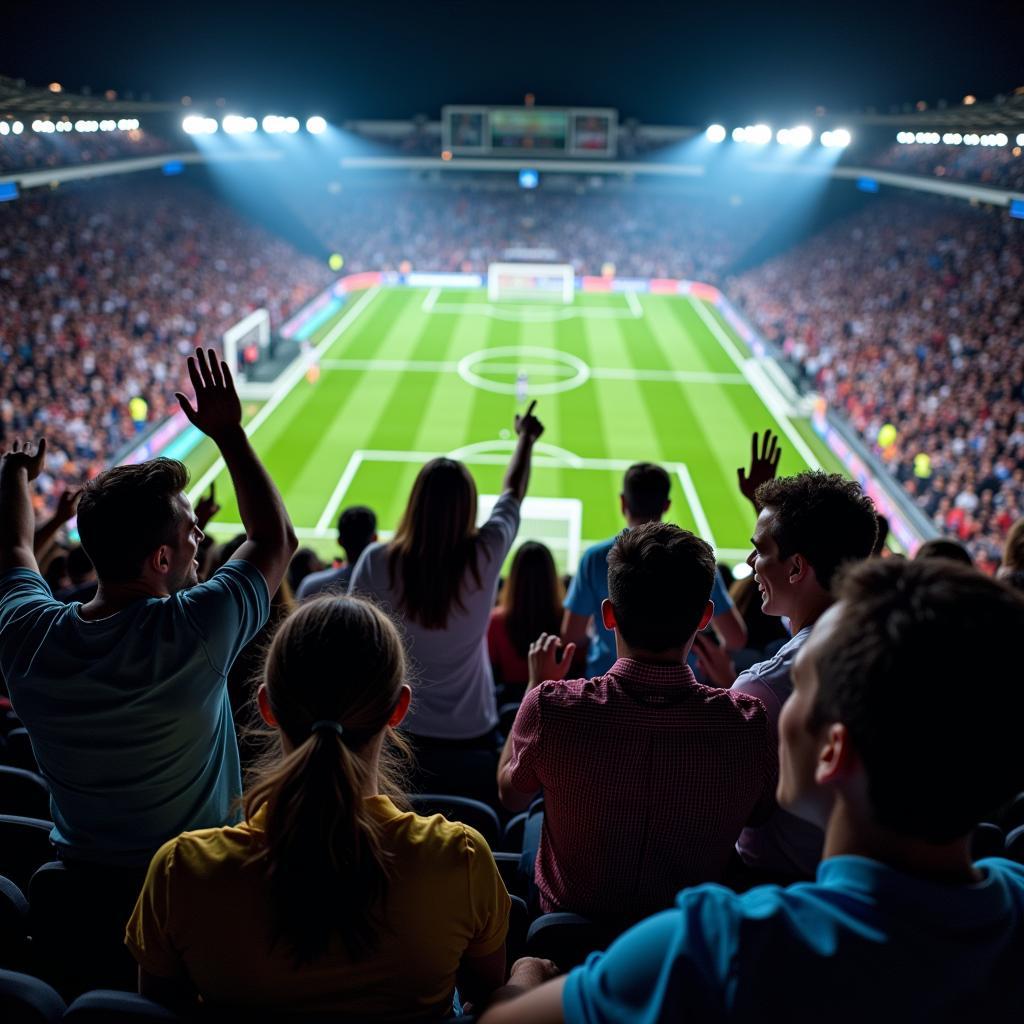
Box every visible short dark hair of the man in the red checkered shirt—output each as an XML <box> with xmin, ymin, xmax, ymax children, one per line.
<box><xmin>608</xmin><ymin>522</ymin><xmax>715</xmax><ymax>650</ymax></box>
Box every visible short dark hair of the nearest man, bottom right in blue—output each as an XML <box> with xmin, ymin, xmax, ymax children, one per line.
<box><xmin>812</xmin><ymin>558</ymin><xmax>1024</xmax><ymax>843</ymax></box>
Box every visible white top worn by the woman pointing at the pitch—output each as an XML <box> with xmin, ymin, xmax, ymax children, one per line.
<box><xmin>348</xmin><ymin>492</ymin><xmax>519</xmax><ymax>739</ymax></box>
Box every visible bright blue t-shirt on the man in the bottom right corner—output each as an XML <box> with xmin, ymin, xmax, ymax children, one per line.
<box><xmin>562</xmin><ymin>856</ymin><xmax>1024</xmax><ymax>1024</ymax></box>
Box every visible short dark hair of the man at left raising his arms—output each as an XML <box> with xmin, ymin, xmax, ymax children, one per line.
<box><xmin>78</xmin><ymin>459</ymin><xmax>188</xmax><ymax>583</ymax></box>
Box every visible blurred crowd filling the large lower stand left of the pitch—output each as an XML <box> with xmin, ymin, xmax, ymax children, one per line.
<box><xmin>0</xmin><ymin>181</ymin><xmax>331</xmax><ymax>516</ymax></box>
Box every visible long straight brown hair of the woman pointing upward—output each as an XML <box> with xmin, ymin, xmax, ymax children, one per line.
<box><xmin>388</xmin><ymin>459</ymin><xmax>480</xmax><ymax>630</ymax></box>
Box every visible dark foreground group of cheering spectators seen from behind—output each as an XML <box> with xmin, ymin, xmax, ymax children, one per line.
<box><xmin>0</xmin><ymin>339</ymin><xmax>1024</xmax><ymax>1024</ymax></box>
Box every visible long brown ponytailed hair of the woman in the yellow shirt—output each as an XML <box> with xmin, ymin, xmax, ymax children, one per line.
<box><xmin>245</xmin><ymin>596</ymin><xmax>408</xmax><ymax>965</ymax></box>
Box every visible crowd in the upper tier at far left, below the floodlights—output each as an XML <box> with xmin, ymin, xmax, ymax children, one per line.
<box><xmin>0</xmin><ymin>129</ymin><xmax>173</xmax><ymax>175</ymax></box>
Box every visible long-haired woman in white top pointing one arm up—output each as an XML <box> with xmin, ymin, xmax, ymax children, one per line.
<box><xmin>349</xmin><ymin>402</ymin><xmax>544</xmax><ymax>802</ymax></box>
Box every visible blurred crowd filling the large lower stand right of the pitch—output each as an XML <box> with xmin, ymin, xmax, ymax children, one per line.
<box><xmin>730</xmin><ymin>200</ymin><xmax>1024</xmax><ymax>569</ymax></box>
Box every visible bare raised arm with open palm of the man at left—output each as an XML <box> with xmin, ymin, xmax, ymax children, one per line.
<box><xmin>175</xmin><ymin>348</ymin><xmax>299</xmax><ymax>594</ymax></box>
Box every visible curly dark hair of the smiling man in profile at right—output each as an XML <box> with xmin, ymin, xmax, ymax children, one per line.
<box><xmin>755</xmin><ymin>471</ymin><xmax>879</xmax><ymax>590</ymax></box>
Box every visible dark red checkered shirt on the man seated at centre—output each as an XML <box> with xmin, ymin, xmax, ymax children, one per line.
<box><xmin>508</xmin><ymin>657</ymin><xmax>778</xmax><ymax>919</ymax></box>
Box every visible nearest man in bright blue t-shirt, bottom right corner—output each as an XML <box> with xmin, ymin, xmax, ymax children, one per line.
<box><xmin>482</xmin><ymin>559</ymin><xmax>1024</xmax><ymax>1024</ymax></box>
